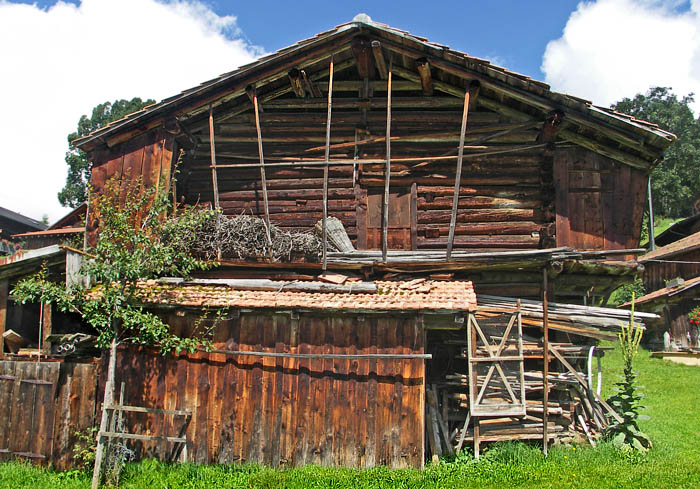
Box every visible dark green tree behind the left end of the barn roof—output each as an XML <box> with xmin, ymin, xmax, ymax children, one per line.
<box><xmin>58</xmin><ymin>97</ymin><xmax>155</xmax><ymax>209</ymax></box>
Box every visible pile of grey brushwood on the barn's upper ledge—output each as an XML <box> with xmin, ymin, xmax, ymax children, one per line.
<box><xmin>192</xmin><ymin>213</ymin><xmax>333</xmax><ymax>261</ymax></box>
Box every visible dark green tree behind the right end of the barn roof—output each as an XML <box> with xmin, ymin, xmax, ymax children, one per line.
<box><xmin>612</xmin><ymin>87</ymin><xmax>700</xmax><ymax>217</ymax></box>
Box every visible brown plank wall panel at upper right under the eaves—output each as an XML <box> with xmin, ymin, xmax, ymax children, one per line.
<box><xmin>554</xmin><ymin>149</ymin><xmax>647</xmax><ymax>250</ymax></box>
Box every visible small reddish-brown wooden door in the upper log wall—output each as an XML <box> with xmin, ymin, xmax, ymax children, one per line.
<box><xmin>366</xmin><ymin>187</ymin><xmax>415</xmax><ymax>250</ymax></box>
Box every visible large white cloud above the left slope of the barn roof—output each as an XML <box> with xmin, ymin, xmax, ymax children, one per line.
<box><xmin>0</xmin><ymin>0</ymin><xmax>261</xmax><ymax>221</ymax></box>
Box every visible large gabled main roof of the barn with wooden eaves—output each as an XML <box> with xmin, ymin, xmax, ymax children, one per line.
<box><xmin>74</xmin><ymin>15</ymin><xmax>675</xmax><ymax>170</ymax></box>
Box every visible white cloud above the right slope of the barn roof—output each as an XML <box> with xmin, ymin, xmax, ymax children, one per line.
<box><xmin>542</xmin><ymin>0</ymin><xmax>700</xmax><ymax>112</ymax></box>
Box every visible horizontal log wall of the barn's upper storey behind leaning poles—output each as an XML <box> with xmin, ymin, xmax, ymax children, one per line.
<box><xmin>178</xmin><ymin>108</ymin><xmax>554</xmax><ymax>249</ymax></box>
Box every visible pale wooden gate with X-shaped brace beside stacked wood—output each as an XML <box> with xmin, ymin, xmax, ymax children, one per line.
<box><xmin>467</xmin><ymin>311</ymin><xmax>525</xmax><ymax>416</ymax></box>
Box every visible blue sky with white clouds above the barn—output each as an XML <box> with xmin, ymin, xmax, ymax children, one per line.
<box><xmin>0</xmin><ymin>0</ymin><xmax>700</xmax><ymax>221</ymax></box>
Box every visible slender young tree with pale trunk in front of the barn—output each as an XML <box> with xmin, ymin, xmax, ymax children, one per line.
<box><xmin>12</xmin><ymin>179</ymin><xmax>213</xmax><ymax>487</ymax></box>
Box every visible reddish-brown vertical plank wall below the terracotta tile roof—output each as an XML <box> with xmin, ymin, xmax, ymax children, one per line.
<box><xmin>111</xmin><ymin>313</ymin><xmax>424</xmax><ymax>467</ymax></box>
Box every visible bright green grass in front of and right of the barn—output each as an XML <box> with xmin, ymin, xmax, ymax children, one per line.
<box><xmin>0</xmin><ymin>344</ymin><xmax>700</xmax><ymax>489</ymax></box>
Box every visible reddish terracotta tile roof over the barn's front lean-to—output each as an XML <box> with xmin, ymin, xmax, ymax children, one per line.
<box><xmin>140</xmin><ymin>280</ymin><xmax>476</xmax><ymax>311</ymax></box>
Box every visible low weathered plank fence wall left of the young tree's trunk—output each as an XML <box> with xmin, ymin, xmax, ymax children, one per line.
<box><xmin>0</xmin><ymin>360</ymin><xmax>97</xmax><ymax>469</ymax></box>
